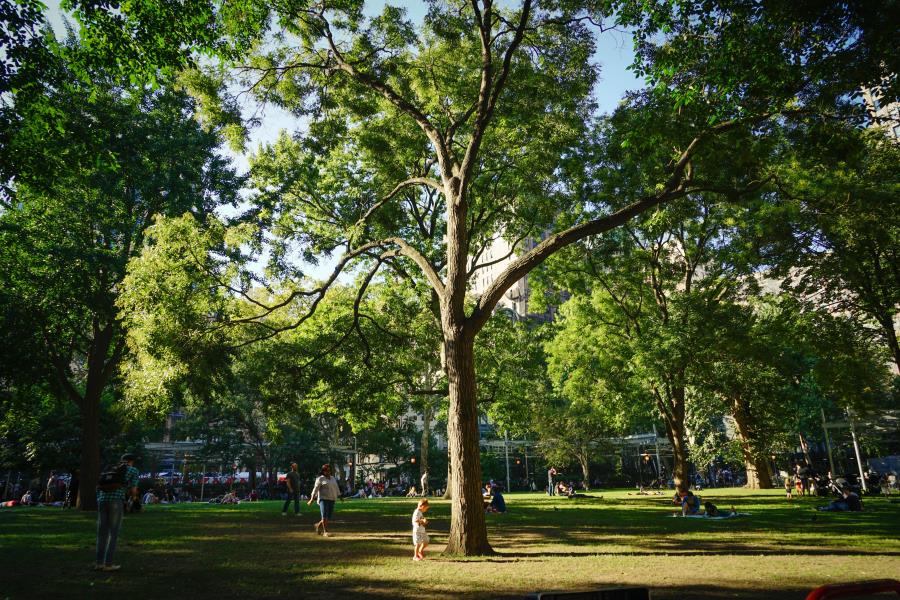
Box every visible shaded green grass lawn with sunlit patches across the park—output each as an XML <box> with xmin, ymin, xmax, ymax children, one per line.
<box><xmin>0</xmin><ymin>489</ymin><xmax>900</xmax><ymax>600</ymax></box>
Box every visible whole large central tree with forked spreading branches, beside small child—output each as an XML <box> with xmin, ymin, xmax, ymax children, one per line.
<box><xmin>75</xmin><ymin>0</ymin><xmax>896</xmax><ymax>554</ymax></box>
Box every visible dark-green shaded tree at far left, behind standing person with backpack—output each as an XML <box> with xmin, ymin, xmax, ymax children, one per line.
<box><xmin>0</xmin><ymin>34</ymin><xmax>238</xmax><ymax>510</ymax></box>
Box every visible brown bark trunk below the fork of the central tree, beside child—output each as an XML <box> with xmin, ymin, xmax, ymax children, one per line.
<box><xmin>445</xmin><ymin>330</ymin><xmax>493</xmax><ymax>556</ymax></box>
